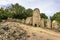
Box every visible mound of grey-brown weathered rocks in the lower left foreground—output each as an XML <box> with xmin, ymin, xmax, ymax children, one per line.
<box><xmin>0</xmin><ymin>25</ymin><xmax>27</xmax><ymax>40</ymax></box>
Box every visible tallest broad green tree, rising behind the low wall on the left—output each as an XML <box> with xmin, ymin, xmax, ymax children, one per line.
<box><xmin>7</xmin><ymin>3</ymin><xmax>25</xmax><ymax>18</ymax></box>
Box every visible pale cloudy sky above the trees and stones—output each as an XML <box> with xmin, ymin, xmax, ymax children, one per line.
<box><xmin>0</xmin><ymin>0</ymin><xmax>60</xmax><ymax>17</ymax></box>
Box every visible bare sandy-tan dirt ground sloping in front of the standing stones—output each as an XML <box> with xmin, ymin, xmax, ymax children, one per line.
<box><xmin>1</xmin><ymin>22</ymin><xmax>60</xmax><ymax>40</ymax></box>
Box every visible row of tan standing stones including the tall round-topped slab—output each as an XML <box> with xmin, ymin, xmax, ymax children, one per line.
<box><xmin>25</xmin><ymin>8</ymin><xmax>59</xmax><ymax>29</ymax></box>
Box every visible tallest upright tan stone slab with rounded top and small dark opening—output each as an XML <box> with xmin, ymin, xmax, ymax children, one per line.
<box><xmin>32</xmin><ymin>8</ymin><xmax>40</xmax><ymax>26</ymax></box>
